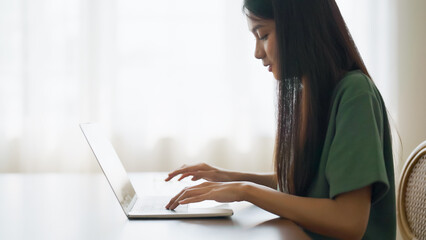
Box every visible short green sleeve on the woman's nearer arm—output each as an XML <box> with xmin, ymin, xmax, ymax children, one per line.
<box><xmin>325</xmin><ymin>92</ymin><xmax>389</xmax><ymax>204</ymax></box>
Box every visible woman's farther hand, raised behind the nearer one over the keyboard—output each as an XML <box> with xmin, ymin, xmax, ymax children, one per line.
<box><xmin>165</xmin><ymin>163</ymin><xmax>232</xmax><ymax>182</ymax></box>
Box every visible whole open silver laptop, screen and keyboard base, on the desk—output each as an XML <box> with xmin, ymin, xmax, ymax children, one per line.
<box><xmin>80</xmin><ymin>123</ymin><xmax>233</xmax><ymax>219</ymax></box>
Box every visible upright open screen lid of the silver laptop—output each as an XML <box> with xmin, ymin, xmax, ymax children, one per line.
<box><xmin>80</xmin><ymin>123</ymin><xmax>136</xmax><ymax>214</ymax></box>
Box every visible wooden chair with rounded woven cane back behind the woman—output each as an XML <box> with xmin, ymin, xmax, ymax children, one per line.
<box><xmin>397</xmin><ymin>141</ymin><xmax>426</xmax><ymax>240</ymax></box>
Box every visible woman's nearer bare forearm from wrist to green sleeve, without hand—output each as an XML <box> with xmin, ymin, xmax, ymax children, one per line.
<box><xmin>242</xmin><ymin>184</ymin><xmax>371</xmax><ymax>239</ymax></box>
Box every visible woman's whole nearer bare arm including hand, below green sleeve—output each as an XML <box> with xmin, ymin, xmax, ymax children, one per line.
<box><xmin>166</xmin><ymin>182</ymin><xmax>371</xmax><ymax>239</ymax></box>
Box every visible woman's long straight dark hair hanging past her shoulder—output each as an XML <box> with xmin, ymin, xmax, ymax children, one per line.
<box><xmin>243</xmin><ymin>0</ymin><xmax>370</xmax><ymax>196</ymax></box>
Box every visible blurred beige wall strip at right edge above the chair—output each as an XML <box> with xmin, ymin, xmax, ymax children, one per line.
<box><xmin>396</xmin><ymin>0</ymin><xmax>426</xmax><ymax>170</ymax></box>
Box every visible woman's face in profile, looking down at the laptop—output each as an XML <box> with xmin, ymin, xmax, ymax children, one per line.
<box><xmin>247</xmin><ymin>13</ymin><xmax>279</xmax><ymax>80</ymax></box>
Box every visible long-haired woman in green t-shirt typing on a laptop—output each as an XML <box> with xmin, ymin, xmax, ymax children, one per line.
<box><xmin>166</xmin><ymin>0</ymin><xmax>396</xmax><ymax>239</ymax></box>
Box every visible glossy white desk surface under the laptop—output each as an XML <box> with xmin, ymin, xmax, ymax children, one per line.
<box><xmin>0</xmin><ymin>173</ymin><xmax>309</xmax><ymax>240</ymax></box>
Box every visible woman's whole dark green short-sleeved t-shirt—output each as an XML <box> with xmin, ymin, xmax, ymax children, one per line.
<box><xmin>307</xmin><ymin>70</ymin><xmax>396</xmax><ymax>239</ymax></box>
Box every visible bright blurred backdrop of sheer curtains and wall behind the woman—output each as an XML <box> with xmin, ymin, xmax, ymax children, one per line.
<box><xmin>0</xmin><ymin>0</ymin><xmax>426</xmax><ymax>173</ymax></box>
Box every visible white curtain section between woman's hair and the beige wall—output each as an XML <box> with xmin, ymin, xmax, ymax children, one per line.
<box><xmin>336</xmin><ymin>0</ymin><xmax>398</xmax><ymax>116</ymax></box>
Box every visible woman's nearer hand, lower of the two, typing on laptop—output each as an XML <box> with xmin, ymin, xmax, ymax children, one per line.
<box><xmin>166</xmin><ymin>182</ymin><xmax>247</xmax><ymax>210</ymax></box>
